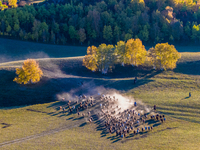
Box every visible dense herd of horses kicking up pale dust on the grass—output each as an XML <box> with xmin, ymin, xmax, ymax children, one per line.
<box><xmin>60</xmin><ymin>94</ymin><xmax>166</xmax><ymax>138</ymax></box>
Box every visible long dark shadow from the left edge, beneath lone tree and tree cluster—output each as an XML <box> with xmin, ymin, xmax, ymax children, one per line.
<box><xmin>0</xmin><ymin>61</ymin><xmax>159</xmax><ymax>107</ymax></box>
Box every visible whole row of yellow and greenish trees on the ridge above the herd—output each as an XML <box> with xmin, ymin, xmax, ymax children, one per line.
<box><xmin>83</xmin><ymin>39</ymin><xmax>181</xmax><ymax>74</ymax></box>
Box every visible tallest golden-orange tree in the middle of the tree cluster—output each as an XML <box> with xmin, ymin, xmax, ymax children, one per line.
<box><xmin>125</xmin><ymin>39</ymin><xmax>147</xmax><ymax>66</ymax></box>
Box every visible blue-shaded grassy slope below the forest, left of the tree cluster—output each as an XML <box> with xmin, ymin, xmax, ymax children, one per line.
<box><xmin>0</xmin><ymin>38</ymin><xmax>87</xmax><ymax>63</ymax></box>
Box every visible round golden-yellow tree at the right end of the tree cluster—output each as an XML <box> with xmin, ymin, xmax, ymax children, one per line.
<box><xmin>148</xmin><ymin>43</ymin><xmax>181</xmax><ymax>70</ymax></box>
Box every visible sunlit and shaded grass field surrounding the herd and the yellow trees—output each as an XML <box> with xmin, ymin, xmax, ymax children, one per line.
<box><xmin>0</xmin><ymin>44</ymin><xmax>200</xmax><ymax>150</ymax></box>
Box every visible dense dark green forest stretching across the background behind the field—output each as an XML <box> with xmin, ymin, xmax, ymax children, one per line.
<box><xmin>0</xmin><ymin>0</ymin><xmax>200</xmax><ymax>45</ymax></box>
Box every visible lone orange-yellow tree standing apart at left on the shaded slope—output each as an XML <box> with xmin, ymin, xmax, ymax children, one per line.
<box><xmin>13</xmin><ymin>59</ymin><xmax>43</xmax><ymax>84</ymax></box>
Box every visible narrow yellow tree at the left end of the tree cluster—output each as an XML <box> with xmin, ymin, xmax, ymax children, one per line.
<box><xmin>83</xmin><ymin>46</ymin><xmax>98</xmax><ymax>72</ymax></box>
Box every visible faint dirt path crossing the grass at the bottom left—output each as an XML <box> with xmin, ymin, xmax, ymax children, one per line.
<box><xmin>0</xmin><ymin>121</ymin><xmax>83</xmax><ymax>148</ymax></box>
